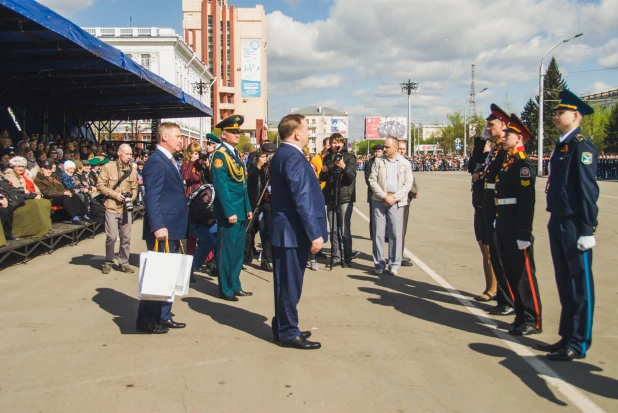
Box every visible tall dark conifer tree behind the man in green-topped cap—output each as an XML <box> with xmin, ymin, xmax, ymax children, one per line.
<box><xmin>536</xmin><ymin>57</ymin><xmax>567</xmax><ymax>152</ymax></box>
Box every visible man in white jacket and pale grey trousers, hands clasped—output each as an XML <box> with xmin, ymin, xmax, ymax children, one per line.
<box><xmin>369</xmin><ymin>137</ymin><xmax>413</xmax><ymax>275</ymax></box>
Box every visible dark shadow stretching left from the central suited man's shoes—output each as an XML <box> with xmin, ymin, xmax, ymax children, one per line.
<box><xmin>182</xmin><ymin>297</ymin><xmax>274</xmax><ymax>344</ymax></box>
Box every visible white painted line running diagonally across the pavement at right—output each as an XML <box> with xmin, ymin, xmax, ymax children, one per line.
<box><xmin>354</xmin><ymin>206</ymin><xmax>606</xmax><ymax>413</ymax></box>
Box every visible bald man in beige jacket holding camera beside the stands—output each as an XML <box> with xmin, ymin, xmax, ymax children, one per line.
<box><xmin>97</xmin><ymin>143</ymin><xmax>137</xmax><ymax>274</ymax></box>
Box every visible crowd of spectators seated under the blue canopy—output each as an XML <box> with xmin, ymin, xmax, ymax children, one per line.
<box><xmin>0</xmin><ymin>130</ymin><xmax>148</xmax><ymax>245</ymax></box>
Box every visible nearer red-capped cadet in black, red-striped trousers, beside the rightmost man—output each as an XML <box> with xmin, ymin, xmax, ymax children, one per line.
<box><xmin>495</xmin><ymin>113</ymin><xmax>542</xmax><ymax>336</ymax></box>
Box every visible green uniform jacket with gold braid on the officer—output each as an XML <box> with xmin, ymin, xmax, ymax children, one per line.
<box><xmin>211</xmin><ymin>144</ymin><xmax>251</xmax><ymax>225</ymax></box>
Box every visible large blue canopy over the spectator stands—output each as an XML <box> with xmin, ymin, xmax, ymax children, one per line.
<box><xmin>0</xmin><ymin>0</ymin><xmax>212</xmax><ymax>121</ymax></box>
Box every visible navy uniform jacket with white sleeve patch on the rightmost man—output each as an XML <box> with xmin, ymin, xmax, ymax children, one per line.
<box><xmin>547</xmin><ymin>128</ymin><xmax>599</xmax><ymax>236</ymax></box>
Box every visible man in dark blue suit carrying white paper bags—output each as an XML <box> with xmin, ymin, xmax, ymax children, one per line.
<box><xmin>136</xmin><ymin>122</ymin><xmax>189</xmax><ymax>334</ymax></box>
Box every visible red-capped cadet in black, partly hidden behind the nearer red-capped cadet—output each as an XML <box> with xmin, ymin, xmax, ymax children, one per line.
<box><xmin>482</xmin><ymin>103</ymin><xmax>515</xmax><ymax>315</ymax></box>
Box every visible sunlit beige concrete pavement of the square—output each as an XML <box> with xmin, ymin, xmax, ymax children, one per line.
<box><xmin>0</xmin><ymin>172</ymin><xmax>618</xmax><ymax>413</ymax></box>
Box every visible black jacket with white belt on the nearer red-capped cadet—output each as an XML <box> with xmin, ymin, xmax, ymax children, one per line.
<box><xmin>494</xmin><ymin>148</ymin><xmax>536</xmax><ymax>241</ymax></box>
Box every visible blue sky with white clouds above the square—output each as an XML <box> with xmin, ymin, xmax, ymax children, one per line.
<box><xmin>40</xmin><ymin>0</ymin><xmax>618</xmax><ymax>140</ymax></box>
